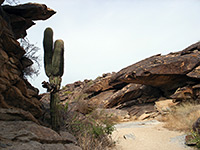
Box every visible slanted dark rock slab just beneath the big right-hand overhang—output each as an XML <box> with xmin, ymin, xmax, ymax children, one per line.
<box><xmin>105</xmin><ymin>83</ymin><xmax>161</xmax><ymax>108</ymax></box>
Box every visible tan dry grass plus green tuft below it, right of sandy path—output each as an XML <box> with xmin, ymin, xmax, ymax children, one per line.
<box><xmin>160</xmin><ymin>102</ymin><xmax>200</xmax><ymax>148</ymax></box>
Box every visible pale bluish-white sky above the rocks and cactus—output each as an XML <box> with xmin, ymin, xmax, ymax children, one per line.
<box><xmin>3</xmin><ymin>0</ymin><xmax>200</xmax><ymax>93</ymax></box>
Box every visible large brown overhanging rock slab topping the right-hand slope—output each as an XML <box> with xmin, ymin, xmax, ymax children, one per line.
<box><xmin>111</xmin><ymin>42</ymin><xmax>200</xmax><ymax>92</ymax></box>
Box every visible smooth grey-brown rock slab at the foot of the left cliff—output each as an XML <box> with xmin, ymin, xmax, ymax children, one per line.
<box><xmin>0</xmin><ymin>121</ymin><xmax>80</xmax><ymax>150</ymax></box>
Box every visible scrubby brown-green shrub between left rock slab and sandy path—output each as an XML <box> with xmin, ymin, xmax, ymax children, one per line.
<box><xmin>66</xmin><ymin>109</ymin><xmax>114</xmax><ymax>150</ymax></box>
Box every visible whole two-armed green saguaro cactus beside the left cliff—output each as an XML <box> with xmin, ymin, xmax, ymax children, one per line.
<box><xmin>42</xmin><ymin>28</ymin><xmax>64</xmax><ymax>131</ymax></box>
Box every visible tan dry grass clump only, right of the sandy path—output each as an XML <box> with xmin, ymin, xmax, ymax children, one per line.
<box><xmin>160</xmin><ymin>103</ymin><xmax>200</xmax><ymax>132</ymax></box>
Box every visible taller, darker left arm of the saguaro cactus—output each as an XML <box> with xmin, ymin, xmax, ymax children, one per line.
<box><xmin>43</xmin><ymin>28</ymin><xmax>53</xmax><ymax>77</ymax></box>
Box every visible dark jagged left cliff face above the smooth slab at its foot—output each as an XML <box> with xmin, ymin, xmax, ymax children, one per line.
<box><xmin>0</xmin><ymin>1</ymin><xmax>55</xmax><ymax>118</ymax></box>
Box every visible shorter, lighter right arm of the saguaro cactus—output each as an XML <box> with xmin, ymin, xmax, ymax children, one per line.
<box><xmin>52</xmin><ymin>40</ymin><xmax>64</xmax><ymax>77</ymax></box>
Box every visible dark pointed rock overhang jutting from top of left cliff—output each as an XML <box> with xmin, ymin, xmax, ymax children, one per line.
<box><xmin>2</xmin><ymin>3</ymin><xmax>56</xmax><ymax>39</ymax></box>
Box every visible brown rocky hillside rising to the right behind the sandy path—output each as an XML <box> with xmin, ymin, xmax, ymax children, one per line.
<box><xmin>39</xmin><ymin>42</ymin><xmax>200</xmax><ymax>119</ymax></box>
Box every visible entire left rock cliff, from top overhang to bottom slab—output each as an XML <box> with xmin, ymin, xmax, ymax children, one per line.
<box><xmin>0</xmin><ymin>0</ymin><xmax>80</xmax><ymax>150</ymax></box>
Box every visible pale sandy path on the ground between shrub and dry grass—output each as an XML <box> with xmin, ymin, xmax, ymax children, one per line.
<box><xmin>112</xmin><ymin>120</ymin><xmax>194</xmax><ymax>150</ymax></box>
